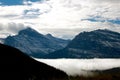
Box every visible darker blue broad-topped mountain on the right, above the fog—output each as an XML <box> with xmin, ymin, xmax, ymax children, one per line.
<box><xmin>46</xmin><ymin>29</ymin><xmax>120</xmax><ymax>58</ymax></box>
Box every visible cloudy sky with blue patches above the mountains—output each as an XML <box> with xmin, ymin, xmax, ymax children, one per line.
<box><xmin>0</xmin><ymin>0</ymin><xmax>120</xmax><ymax>39</ymax></box>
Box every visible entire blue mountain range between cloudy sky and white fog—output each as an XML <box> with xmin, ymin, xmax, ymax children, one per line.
<box><xmin>1</xmin><ymin>28</ymin><xmax>120</xmax><ymax>58</ymax></box>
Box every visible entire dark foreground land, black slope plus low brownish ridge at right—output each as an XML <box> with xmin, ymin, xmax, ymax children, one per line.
<box><xmin>0</xmin><ymin>44</ymin><xmax>120</xmax><ymax>80</ymax></box>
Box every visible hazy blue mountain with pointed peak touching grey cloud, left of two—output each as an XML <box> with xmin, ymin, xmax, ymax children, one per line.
<box><xmin>4</xmin><ymin>28</ymin><xmax>69</xmax><ymax>58</ymax></box>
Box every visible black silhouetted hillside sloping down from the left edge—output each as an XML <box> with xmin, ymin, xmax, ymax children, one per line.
<box><xmin>0</xmin><ymin>44</ymin><xmax>68</xmax><ymax>80</ymax></box>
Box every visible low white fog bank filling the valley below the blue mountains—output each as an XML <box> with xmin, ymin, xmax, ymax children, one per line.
<box><xmin>36</xmin><ymin>59</ymin><xmax>120</xmax><ymax>76</ymax></box>
